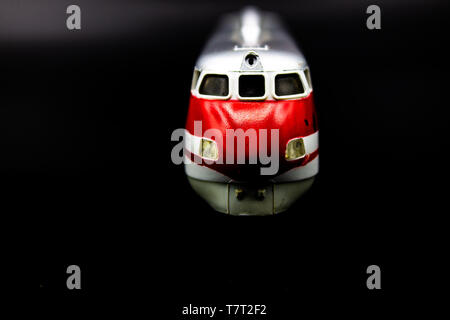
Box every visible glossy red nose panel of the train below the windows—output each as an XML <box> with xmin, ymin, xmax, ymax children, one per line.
<box><xmin>186</xmin><ymin>93</ymin><xmax>318</xmax><ymax>180</ymax></box>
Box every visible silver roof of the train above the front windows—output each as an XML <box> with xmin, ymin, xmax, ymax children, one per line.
<box><xmin>196</xmin><ymin>8</ymin><xmax>307</xmax><ymax>72</ymax></box>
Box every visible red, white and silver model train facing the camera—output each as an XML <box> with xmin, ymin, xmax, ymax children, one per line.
<box><xmin>184</xmin><ymin>8</ymin><xmax>319</xmax><ymax>215</ymax></box>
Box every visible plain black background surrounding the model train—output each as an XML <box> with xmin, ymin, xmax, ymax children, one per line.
<box><xmin>10</xmin><ymin>1</ymin><xmax>449</xmax><ymax>319</ymax></box>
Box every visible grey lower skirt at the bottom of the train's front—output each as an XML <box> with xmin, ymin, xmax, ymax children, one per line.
<box><xmin>187</xmin><ymin>176</ymin><xmax>314</xmax><ymax>215</ymax></box>
